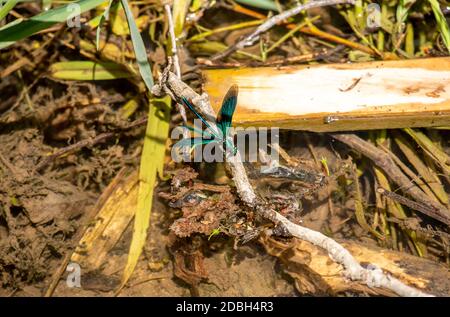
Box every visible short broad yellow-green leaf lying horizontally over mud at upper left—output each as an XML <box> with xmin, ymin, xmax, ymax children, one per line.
<box><xmin>50</xmin><ymin>61</ymin><xmax>134</xmax><ymax>80</ymax></box>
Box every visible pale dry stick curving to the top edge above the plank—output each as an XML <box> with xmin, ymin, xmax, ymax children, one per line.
<box><xmin>211</xmin><ymin>0</ymin><xmax>355</xmax><ymax>61</ymax></box>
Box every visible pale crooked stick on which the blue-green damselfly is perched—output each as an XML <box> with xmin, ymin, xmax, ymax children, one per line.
<box><xmin>152</xmin><ymin>70</ymin><xmax>432</xmax><ymax>296</ymax></box>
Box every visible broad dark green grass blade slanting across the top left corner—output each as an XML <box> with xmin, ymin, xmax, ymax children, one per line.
<box><xmin>0</xmin><ymin>0</ymin><xmax>105</xmax><ymax>49</ymax></box>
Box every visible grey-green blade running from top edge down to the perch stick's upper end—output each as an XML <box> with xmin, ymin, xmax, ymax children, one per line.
<box><xmin>120</xmin><ymin>0</ymin><xmax>153</xmax><ymax>90</ymax></box>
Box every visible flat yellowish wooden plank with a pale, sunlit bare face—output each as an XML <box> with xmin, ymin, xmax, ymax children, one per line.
<box><xmin>203</xmin><ymin>57</ymin><xmax>450</xmax><ymax>132</ymax></box>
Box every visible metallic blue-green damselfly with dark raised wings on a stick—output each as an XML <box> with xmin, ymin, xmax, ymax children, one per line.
<box><xmin>175</xmin><ymin>85</ymin><xmax>238</xmax><ymax>155</ymax></box>
